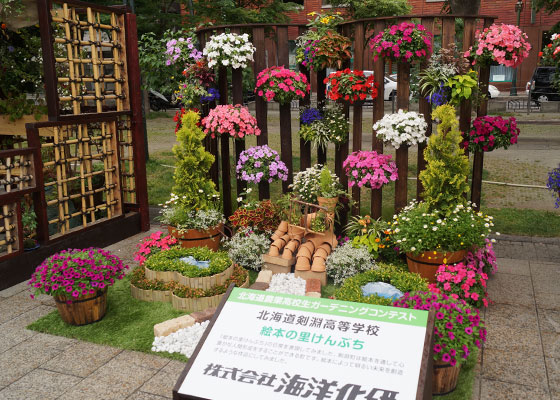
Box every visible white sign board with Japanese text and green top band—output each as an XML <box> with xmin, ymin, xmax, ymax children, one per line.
<box><xmin>174</xmin><ymin>288</ymin><xmax>433</xmax><ymax>400</ymax></box>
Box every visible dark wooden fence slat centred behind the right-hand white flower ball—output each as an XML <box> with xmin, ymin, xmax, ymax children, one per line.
<box><xmin>395</xmin><ymin>62</ymin><xmax>410</xmax><ymax>213</ymax></box>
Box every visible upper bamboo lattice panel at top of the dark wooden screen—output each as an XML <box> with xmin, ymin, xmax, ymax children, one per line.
<box><xmin>51</xmin><ymin>2</ymin><xmax>130</xmax><ymax>114</ymax></box>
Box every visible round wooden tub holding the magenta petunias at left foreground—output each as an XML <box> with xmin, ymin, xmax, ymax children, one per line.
<box><xmin>54</xmin><ymin>289</ymin><xmax>107</xmax><ymax>325</ymax></box>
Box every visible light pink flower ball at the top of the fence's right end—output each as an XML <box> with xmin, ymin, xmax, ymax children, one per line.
<box><xmin>465</xmin><ymin>24</ymin><xmax>531</xmax><ymax>68</ymax></box>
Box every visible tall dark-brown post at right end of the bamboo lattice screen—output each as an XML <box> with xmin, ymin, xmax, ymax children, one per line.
<box><xmin>125</xmin><ymin>13</ymin><xmax>150</xmax><ymax>231</ymax></box>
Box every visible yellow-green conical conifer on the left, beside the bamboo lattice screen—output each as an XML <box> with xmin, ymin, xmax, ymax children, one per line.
<box><xmin>173</xmin><ymin>110</ymin><xmax>218</xmax><ymax>211</ymax></box>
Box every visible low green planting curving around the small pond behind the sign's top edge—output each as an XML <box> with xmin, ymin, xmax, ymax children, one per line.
<box><xmin>335</xmin><ymin>264</ymin><xmax>428</xmax><ymax>306</ymax></box>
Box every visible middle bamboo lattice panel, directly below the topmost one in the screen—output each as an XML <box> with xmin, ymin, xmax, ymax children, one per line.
<box><xmin>39</xmin><ymin>118</ymin><xmax>122</xmax><ymax>236</ymax></box>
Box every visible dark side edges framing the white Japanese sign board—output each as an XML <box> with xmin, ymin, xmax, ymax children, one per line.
<box><xmin>173</xmin><ymin>283</ymin><xmax>435</xmax><ymax>400</ymax></box>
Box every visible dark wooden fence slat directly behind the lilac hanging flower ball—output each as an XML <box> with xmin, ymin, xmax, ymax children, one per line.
<box><xmin>253</xmin><ymin>27</ymin><xmax>270</xmax><ymax>200</ymax></box>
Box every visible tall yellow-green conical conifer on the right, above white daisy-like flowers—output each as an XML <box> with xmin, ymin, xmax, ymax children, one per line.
<box><xmin>420</xmin><ymin>105</ymin><xmax>469</xmax><ymax>215</ymax></box>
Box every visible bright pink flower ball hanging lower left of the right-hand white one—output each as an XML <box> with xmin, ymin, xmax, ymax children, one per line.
<box><xmin>342</xmin><ymin>151</ymin><xmax>398</xmax><ymax>189</ymax></box>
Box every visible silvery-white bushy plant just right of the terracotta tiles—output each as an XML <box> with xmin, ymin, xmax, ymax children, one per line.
<box><xmin>326</xmin><ymin>242</ymin><xmax>378</xmax><ymax>285</ymax></box>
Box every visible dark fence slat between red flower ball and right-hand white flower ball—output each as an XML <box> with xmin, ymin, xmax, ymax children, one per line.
<box><xmin>371</xmin><ymin>21</ymin><xmax>385</xmax><ymax>219</ymax></box>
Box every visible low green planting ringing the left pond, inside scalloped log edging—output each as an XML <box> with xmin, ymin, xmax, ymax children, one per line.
<box><xmin>144</xmin><ymin>247</ymin><xmax>232</xmax><ymax>278</ymax></box>
